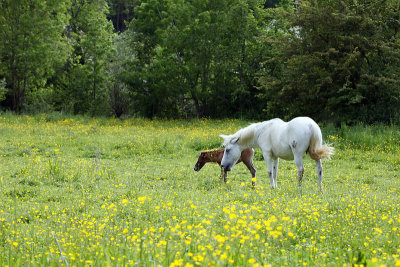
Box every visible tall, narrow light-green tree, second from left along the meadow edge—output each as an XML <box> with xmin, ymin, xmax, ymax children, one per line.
<box><xmin>53</xmin><ymin>0</ymin><xmax>114</xmax><ymax>115</ymax></box>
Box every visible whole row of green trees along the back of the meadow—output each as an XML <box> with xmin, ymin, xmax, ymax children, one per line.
<box><xmin>0</xmin><ymin>0</ymin><xmax>400</xmax><ymax>123</ymax></box>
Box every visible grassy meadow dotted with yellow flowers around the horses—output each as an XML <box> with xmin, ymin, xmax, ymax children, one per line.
<box><xmin>0</xmin><ymin>114</ymin><xmax>400</xmax><ymax>266</ymax></box>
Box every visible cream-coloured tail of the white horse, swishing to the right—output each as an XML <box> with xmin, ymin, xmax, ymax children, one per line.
<box><xmin>308</xmin><ymin>123</ymin><xmax>335</xmax><ymax>160</ymax></box>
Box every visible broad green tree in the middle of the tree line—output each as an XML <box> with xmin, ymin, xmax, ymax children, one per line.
<box><xmin>127</xmin><ymin>0</ymin><xmax>270</xmax><ymax>117</ymax></box>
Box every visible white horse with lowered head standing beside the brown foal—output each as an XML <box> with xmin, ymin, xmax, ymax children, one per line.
<box><xmin>220</xmin><ymin>117</ymin><xmax>334</xmax><ymax>190</ymax></box>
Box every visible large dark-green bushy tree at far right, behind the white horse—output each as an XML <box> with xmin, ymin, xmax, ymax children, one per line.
<box><xmin>261</xmin><ymin>0</ymin><xmax>400</xmax><ymax>122</ymax></box>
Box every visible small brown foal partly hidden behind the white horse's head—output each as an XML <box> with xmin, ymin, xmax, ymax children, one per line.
<box><xmin>194</xmin><ymin>148</ymin><xmax>256</xmax><ymax>187</ymax></box>
